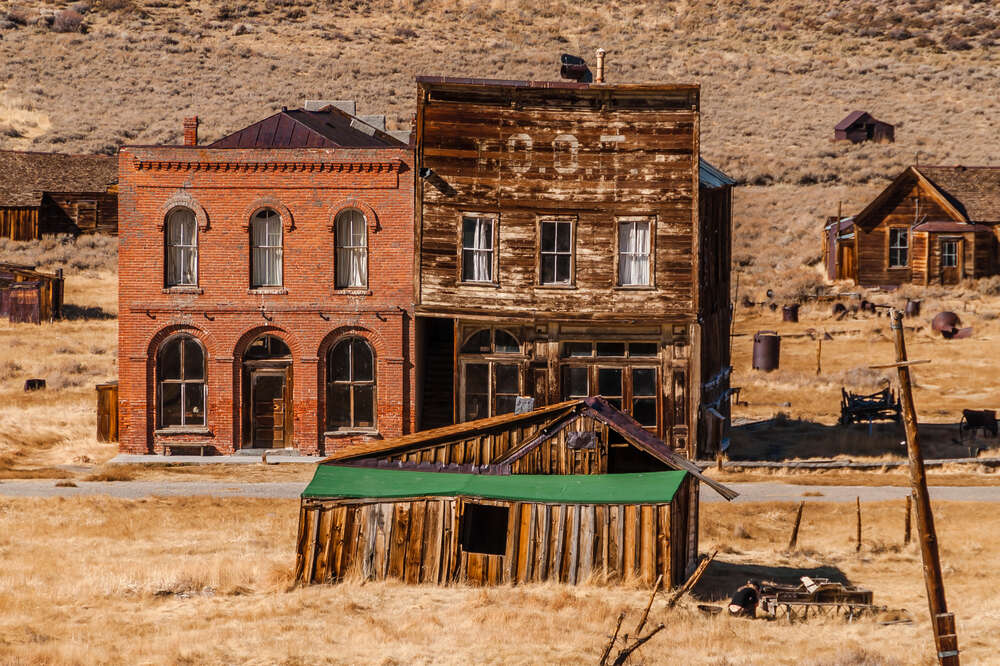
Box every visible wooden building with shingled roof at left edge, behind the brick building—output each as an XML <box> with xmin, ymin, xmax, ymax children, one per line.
<box><xmin>0</xmin><ymin>150</ymin><xmax>118</xmax><ymax>240</ymax></box>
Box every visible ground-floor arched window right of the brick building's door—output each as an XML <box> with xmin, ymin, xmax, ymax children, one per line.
<box><xmin>326</xmin><ymin>338</ymin><xmax>375</xmax><ymax>430</ymax></box>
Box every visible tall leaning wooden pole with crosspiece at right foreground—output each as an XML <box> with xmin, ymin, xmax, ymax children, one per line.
<box><xmin>892</xmin><ymin>309</ymin><xmax>959</xmax><ymax>666</ymax></box>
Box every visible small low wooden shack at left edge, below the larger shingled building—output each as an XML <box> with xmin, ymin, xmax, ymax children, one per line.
<box><xmin>0</xmin><ymin>264</ymin><xmax>64</xmax><ymax>324</ymax></box>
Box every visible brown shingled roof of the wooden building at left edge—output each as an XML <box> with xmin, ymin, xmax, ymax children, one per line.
<box><xmin>0</xmin><ymin>150</ymin><xmax>118</xmax><ymax>206</ymax></box>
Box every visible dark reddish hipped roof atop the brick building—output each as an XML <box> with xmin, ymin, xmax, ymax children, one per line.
<box><xmin>208</xmin><ymin>105</ymin><xmax>406</xmax><ymax>148</ymax></box>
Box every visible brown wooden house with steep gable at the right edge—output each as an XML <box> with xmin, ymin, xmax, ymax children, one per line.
<box><xmin>823</xmin><ymin>165</ymin><xmax>1000</xmax><ymax>286</ymax></box>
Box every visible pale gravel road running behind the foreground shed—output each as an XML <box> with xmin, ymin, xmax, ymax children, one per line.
<box><xmin>0</xmin><ymin>479</ymin><xmax>1000</xmax><ymax>502</ymax></box>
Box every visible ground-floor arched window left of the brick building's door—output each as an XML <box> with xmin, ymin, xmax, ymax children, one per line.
<box><xmin>156</xmin><ymin>335</ymin><xmax>205</xmax><ymax>428</ymax></box>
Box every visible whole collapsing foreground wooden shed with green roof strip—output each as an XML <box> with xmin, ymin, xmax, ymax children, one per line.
<box><xmin>295</xmin><ymin>398</ymin><xmax>736</xmax><ymax>585</ymax></box>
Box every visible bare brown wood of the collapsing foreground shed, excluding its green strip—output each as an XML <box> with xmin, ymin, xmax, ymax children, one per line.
<box><xmin>297</xmin><ymin>398</ymin><xmax>735</xmax><ymax>584</ymax></box>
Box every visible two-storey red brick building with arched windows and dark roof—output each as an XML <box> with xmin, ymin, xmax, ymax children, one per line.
<box><xmin>119</xmin><ymin>103</ymin><xmax>414</xmax><ymax>453</ymax></box>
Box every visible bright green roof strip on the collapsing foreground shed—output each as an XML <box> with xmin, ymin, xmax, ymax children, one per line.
<box><xmin>302</xmin><ymin>465</ymin><xmax>687</xmax><ymax>504</ymax></box>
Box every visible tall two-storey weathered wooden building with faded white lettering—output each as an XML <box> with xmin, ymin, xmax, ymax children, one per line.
<box><xmin>415</xmin><ymin>77</ymin><xmax>733</xmax><ymax>457</ymax></box>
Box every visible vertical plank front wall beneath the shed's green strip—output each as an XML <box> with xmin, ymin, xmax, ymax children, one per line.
<box><xmin>296</xmin><ymin>497</ymin><xmax>683</xmax><ymax>586</ymax></box>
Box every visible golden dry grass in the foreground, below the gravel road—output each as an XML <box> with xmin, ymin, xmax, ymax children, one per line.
<box><xmin>0</xmin><ymin>498</ymin><xmax>988</xmax><ymax>666</ymax></box>
